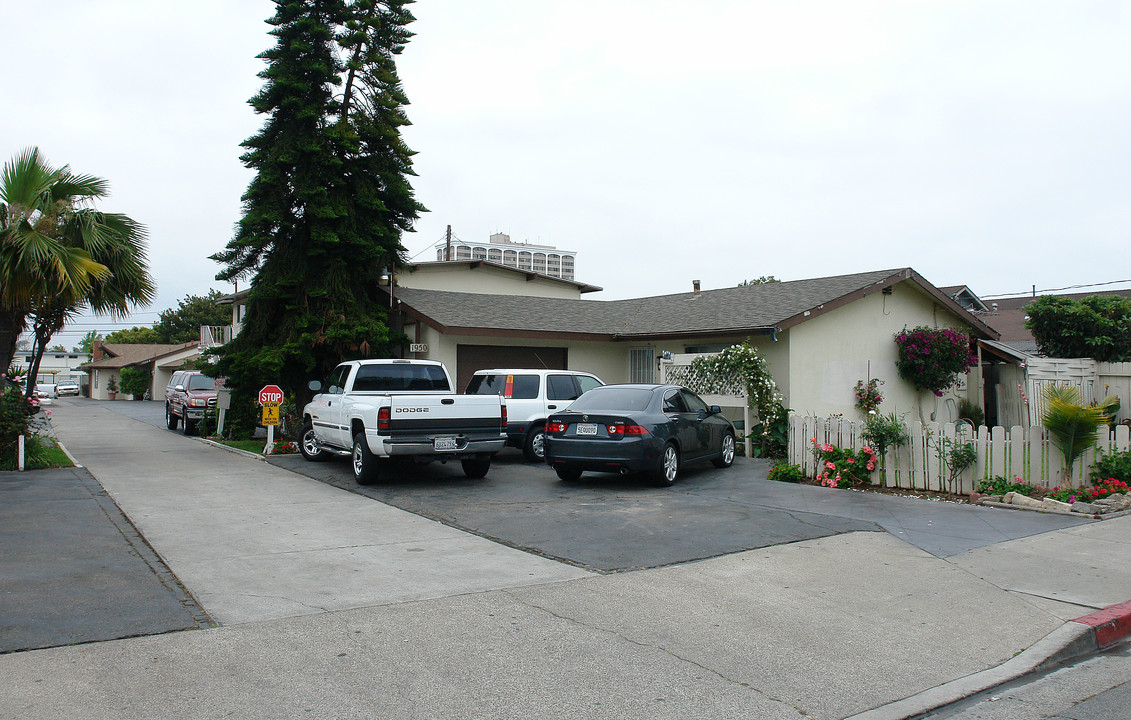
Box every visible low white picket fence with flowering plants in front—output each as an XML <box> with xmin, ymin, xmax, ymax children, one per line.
<box><xmin>788</xmin><ymin>415</ymin><xmax>1131</xmax><ymax>494</ymax></box>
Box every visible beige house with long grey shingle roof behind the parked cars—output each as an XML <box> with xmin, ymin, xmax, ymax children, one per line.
<box><xmin>392</xmin><ymin>263</ymin><xmax>999</xmax><ymax>420</ymax></box>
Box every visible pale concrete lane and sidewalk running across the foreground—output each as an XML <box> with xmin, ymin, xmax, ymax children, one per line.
<box><xmin>0</xmin><ymin>401</ymin><xmax>1131</xmax><ymax>720</ymax></box>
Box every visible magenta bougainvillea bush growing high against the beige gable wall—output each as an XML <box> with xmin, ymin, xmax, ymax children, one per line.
<box><xmin>896</xmin><ymin>326</ymin><xmax>978</xmax><ymax>396</ymax></box>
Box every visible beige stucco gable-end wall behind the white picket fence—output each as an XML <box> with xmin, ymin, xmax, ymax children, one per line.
<box><xmin>775</xmin><ymin>281</ymin><xmax>977</xmax><ymax>422</ymax></box>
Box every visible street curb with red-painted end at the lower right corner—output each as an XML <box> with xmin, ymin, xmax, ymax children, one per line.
<box><xmin>844</xmin><ymin>600</ymin><xmax>1131</xmax><ymax>720</ymax></box>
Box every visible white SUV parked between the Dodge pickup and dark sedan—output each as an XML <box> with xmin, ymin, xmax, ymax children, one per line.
<box><xmin>467</xmin><ymin>368</ymin><xmax>605</xmax><ymax>462</ymax></box>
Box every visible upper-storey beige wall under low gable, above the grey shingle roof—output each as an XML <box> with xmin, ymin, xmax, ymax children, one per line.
<box><xmin>394</xmin><ymin>263</ymin><xmax>581</xmax><ymax>300</ymax></box>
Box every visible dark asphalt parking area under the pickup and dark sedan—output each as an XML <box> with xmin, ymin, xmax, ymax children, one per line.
<box><xmin>269</xmin><ymin>440</ymin><xmax>1093</xmax><ymax>572</ymax></box>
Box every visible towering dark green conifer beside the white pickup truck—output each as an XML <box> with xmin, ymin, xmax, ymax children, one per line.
<box><xmin>213</xmin><ymin>0</ymin><xmax>425</xmax><ymax>409</ymax></box>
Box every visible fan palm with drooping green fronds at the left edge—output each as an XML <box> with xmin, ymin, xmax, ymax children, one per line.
<box><xmin>0</xmin><ymin>148</ymin><xmax>156</xmax><ymax>372</ymax></box>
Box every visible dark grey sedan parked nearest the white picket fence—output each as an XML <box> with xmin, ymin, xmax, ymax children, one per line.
<box><xmin>545</xmin><ymin>384</ymin><xmax>734</xmax><ymax>485</ymax></box>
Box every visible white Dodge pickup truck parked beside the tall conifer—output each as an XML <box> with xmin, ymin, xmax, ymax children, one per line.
<box><xmin>299</xmin><ymin>359</ymin><xmax>507</xmax><ymax>485</ymax></box>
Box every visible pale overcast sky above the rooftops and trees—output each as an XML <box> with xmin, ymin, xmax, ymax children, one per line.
<box><xmin>0</xmin><ymin>0</ymin><xmax>1131</xmax><ymax>347</ymax></box>
